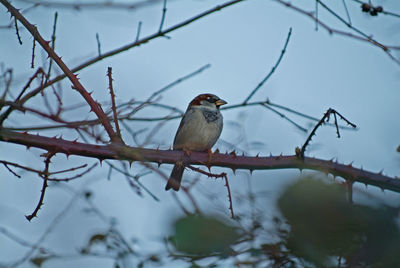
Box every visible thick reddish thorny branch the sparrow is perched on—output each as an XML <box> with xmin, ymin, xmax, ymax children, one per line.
<box><xmin>0</xmin><ymin>129</ymin><xmax>400</xmax><ymax>192</ymax></box>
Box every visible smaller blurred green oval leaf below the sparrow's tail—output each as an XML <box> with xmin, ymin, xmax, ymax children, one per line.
<box><xmin>172</xmin><ymin>215</ymin><xmax>239</xmax><ymax>255</ymax></box>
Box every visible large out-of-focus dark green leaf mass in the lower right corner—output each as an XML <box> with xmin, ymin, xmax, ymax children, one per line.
<box><xmin>278</xmin><ymin>178</ymin><xmax>400</xmax><ymax>267</ymax></box>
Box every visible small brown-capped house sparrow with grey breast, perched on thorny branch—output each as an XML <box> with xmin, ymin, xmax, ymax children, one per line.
<box><xmin>165</xmin><ymin>94</ymin><xmax>227</xmax><ymax>191</ymax></box>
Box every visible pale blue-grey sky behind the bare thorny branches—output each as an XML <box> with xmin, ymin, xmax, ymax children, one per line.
<box><xmin>0</xmin><ymin>0</ymin><xmax>400</xmax><ymax>267</ymax></box>
